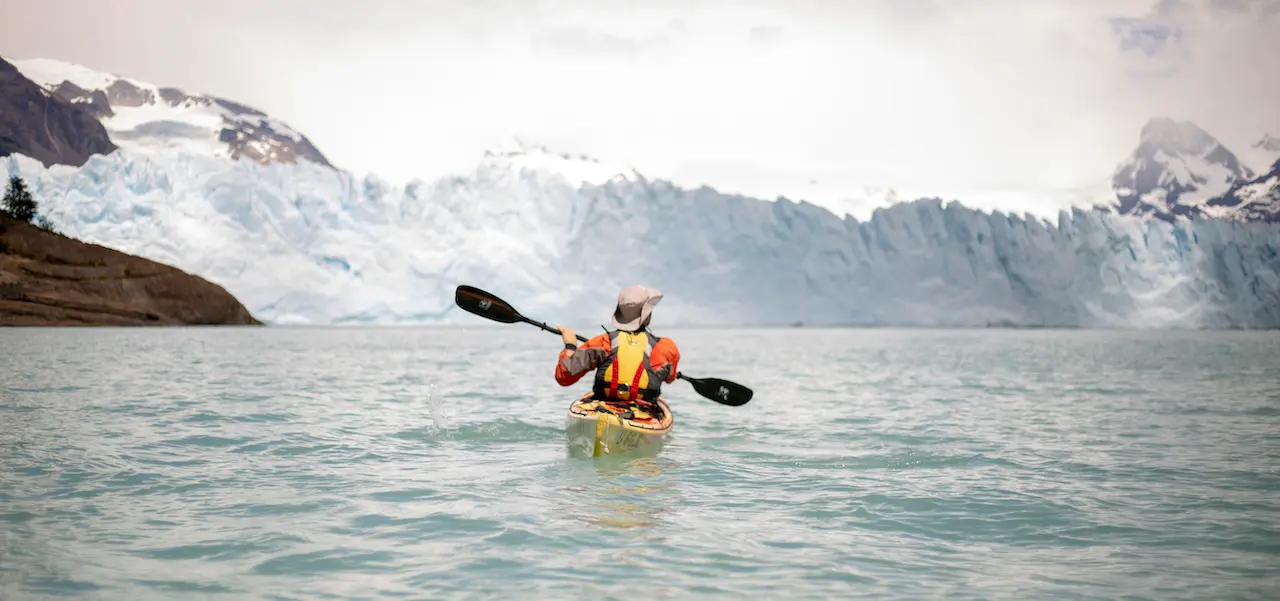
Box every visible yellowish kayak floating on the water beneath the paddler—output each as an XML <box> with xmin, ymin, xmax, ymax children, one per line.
<box><xmin>564</xmin><ymin>394</ymin><xmax>676</xmax><ymax>457</ymax></box>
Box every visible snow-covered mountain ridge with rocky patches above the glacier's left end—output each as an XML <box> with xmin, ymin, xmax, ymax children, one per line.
<box><xmin>12</xmin><ymin>59</ymin><xmax>330</xmax><ymax>166</ymax></box>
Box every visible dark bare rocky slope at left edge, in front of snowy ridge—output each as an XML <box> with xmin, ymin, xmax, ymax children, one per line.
<box><xmin>0</xmin><ymin>59</ymin><xmax>115</xmax><ymax>168</ymax></box>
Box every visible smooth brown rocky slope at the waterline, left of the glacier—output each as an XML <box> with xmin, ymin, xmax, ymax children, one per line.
<box><xmin>0</xmin><ymin>214</ymin><xmax>260</xmax><ymax>326</ymax></box>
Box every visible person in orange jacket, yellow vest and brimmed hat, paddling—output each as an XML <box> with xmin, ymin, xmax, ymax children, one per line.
<box><xmin>556</xmin><ymin>285</ymin><xmax>680</xmax><ymax>407</ymax></box>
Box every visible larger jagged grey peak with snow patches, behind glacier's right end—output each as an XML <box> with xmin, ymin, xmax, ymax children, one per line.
<box><xmin>1112</xmin><ymin>118</ymin><xmax>1254</xmax><ymax>220</ymax></box>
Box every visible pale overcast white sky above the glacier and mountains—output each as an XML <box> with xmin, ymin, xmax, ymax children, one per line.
<box><xmin>0</xmin><ymin>0</ymin><xmax>1280</xmax><ymax>221</ymax></box>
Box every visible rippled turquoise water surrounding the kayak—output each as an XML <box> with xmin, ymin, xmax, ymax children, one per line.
<box><xmin>0</xmin><ymin>326</ymin><xmax>1280</xmax><ymax>601</ymax></box>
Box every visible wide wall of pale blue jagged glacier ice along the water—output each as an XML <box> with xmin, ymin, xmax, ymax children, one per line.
<box><xmin>4</xmin><ymin>148</ymin><xmax>1280</xmax><ymax>331</ymax></box>
